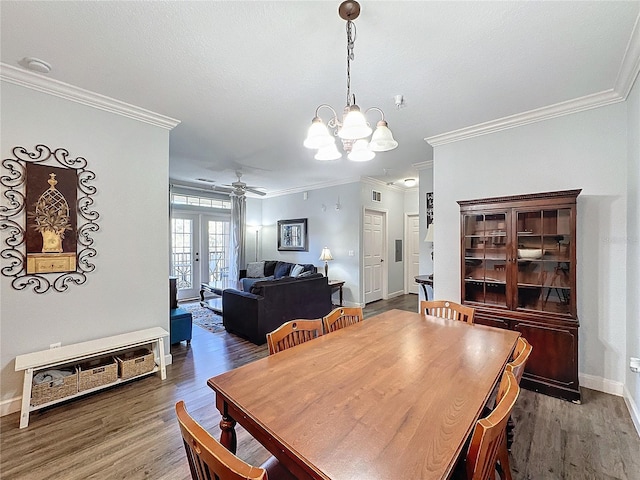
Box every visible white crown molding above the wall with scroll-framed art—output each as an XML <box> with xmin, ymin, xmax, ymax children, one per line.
<box><xmin>0</xmin><ymin>62</ymin><xmax>180</xmax><ymax>130</ymax></box>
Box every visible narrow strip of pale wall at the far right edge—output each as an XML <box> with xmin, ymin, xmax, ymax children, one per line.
<box><xmin>625</xmin><ymin>78</ymin><xmax>640</xmax><ymax>434</ymax></box>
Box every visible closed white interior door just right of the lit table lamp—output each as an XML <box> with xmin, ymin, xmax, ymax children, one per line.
<box><xmin>362</xmin><ymin>210</ymin><xmax>386</xmax><ymax>303</ymax></box>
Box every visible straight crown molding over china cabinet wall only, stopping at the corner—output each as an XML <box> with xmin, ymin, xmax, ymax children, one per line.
<box><xmin>424</xmin><ymin>89</ymin><xmax>624</xmax><ymax>147</ymax></box>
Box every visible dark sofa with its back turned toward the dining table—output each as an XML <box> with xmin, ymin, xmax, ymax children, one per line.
<box><xmin>222</xmin><ymin>273</ymin><xmax>333</xmax><ymax>345</ymax></box>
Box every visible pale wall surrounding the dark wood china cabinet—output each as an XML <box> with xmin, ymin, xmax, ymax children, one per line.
<box><xmin>432</xmin><ymin>102</ymin><xmax>637</xmax><ymax>393</ymax></box>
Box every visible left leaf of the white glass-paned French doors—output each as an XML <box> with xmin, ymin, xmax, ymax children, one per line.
<box><xmin>170</xmin><ymin>212</ymin><xmax>201</xmax><ymax>300</ymax></box>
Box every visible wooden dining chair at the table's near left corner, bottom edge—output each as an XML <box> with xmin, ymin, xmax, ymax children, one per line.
<box><xmin>176</xmin><ymin>400</ymin><xmax>295</xmax><ymax>480</ymax></box>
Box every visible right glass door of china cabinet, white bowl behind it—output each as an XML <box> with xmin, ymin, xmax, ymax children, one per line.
<box><xmin>517</xmin><ymin>208</ymin><xmax>573</xmax><ymax>314</ymax></box>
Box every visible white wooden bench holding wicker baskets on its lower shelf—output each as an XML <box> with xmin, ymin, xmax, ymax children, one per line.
<box><xmin>16</xmin><ymin>327</ymin><xmax>169</xmax><ymax>428</ymax></box>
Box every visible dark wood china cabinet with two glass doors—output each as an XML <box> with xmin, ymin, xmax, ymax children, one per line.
<box><xmin>458</xmin><ymin>190</ymin><xmax>580</xmax><ymax>403</ymax></box>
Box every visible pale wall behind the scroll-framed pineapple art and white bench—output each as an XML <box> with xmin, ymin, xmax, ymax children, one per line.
<box><xmin>0</xmin><ymin>81</ymin><xmax>169</xmax><ymax>413</ymax></box>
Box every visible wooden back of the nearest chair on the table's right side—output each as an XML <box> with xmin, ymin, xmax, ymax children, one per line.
<box><xmin>466</xmin><ymin>370</ymin><xmax>520</xmax><ymax>480</ymax></box>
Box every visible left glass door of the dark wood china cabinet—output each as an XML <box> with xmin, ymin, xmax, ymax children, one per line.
<box><xmin>463</xmin><ymin>212</ymin><xmax>507</xmax><ymax>306</ymax></box>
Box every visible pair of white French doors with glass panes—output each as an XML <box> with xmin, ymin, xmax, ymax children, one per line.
<box><xmin>171</xmin><ymin>212</ymin><xmax>230</xmax><ymax>300</ymax></box>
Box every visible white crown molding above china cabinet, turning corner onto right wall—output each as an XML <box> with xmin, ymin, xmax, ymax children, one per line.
<box><xmin>424</xmin><ymin>15</ymin><xmax>640</xmax><ymax>147</ymax></box>
